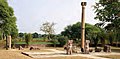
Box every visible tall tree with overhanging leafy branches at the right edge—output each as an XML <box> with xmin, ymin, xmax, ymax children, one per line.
<box><xmin>94</xmin><ymin>0</ymin><xmax>120</xmax><ymax>43</ymax></box>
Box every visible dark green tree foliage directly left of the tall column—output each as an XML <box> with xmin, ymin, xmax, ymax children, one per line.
<box><xmin>61</xmin><ymin>22</ymin><xmax>81</xmax><ymax>39</ymax></box>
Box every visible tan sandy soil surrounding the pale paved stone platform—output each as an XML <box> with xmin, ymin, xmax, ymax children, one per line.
<box><xmin>0</xmin><ymin>49</ymin><xmax>120</xmax><ymax>59</ymax></box>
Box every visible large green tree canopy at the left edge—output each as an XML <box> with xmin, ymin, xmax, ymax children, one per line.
<box><xmin>0</xmin><ymin>0</ymin><xmax>18</xmax><ymax>38</ymax></box>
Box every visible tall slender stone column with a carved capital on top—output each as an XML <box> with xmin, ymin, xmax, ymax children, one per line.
<box><xmin>81</xmin><ymin>2</ymin><xmax>87</xmax><ymax>52</ymax></box>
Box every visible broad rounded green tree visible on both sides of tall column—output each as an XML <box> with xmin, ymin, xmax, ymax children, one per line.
<box><xmin>61</xmin><ymin>22</ymin><xmax>101</xmax><ymax>42</ymax></box>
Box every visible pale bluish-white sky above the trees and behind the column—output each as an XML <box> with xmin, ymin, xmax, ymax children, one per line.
<box><xmin>8</xmin><ymin>0</ymin><xmax>98</xmax><ymax>34</ymax></box>
